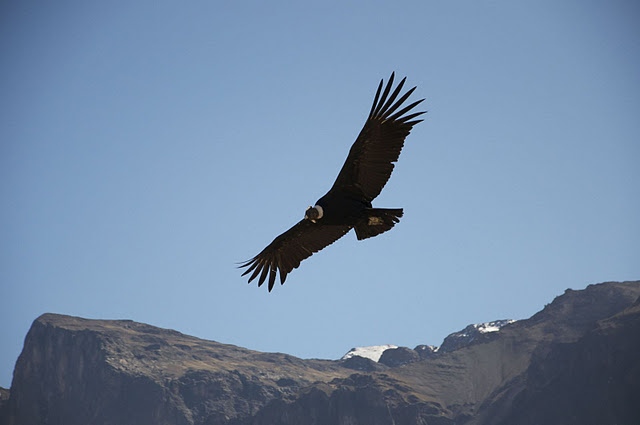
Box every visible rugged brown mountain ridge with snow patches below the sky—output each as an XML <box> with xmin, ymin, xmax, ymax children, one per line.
<box><xmin>0</xmin><ymin>282</ymin><xmax>640</xmax><ymax>425</ymax></box>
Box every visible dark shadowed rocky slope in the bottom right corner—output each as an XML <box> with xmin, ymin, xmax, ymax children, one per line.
<box><xmin>475</xmin><ymin>299</ymin><xmax>640</xmax><ymax>425</ymax></box>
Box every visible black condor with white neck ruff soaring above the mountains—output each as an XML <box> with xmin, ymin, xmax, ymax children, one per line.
<box><xmin>240</xmin><ymin>73</ymin><xmax>425</xmax><ymax>292</ymax></box>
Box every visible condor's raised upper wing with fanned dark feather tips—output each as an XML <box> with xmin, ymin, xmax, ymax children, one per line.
<box><xmin>331</xmin><ymin>74</ymin><xmax>424</xmax><ymax>202</ymax></box>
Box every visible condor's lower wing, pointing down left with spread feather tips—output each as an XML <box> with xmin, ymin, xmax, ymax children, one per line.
<box><xmin>240</xmin><ymin>219</ymin><xmax>351</xmax><ymax>292</ymax></box>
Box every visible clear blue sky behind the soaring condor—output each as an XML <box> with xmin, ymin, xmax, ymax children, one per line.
<box><xmin>0</xmin><ymin>0</ymin><xmax>640</xmax><ymax>387</ymax></box>
